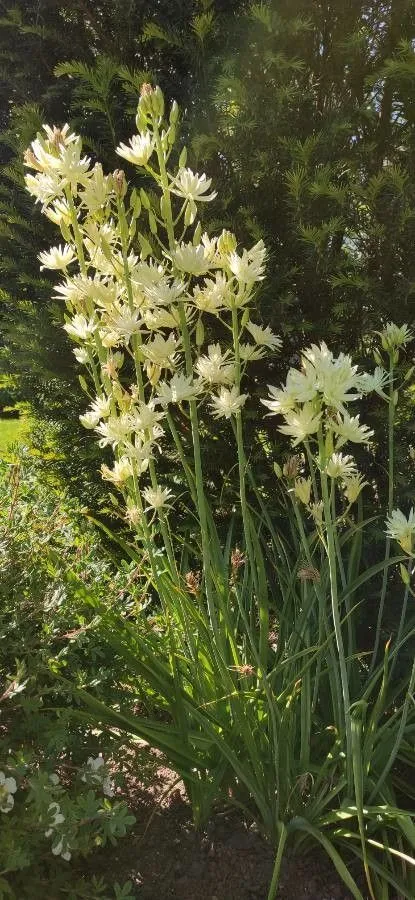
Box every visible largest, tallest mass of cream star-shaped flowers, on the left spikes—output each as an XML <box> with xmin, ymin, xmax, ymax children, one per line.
<box><xmin>25</xmin><ymin>85</ymin><xmax>281</xmax><ymax>523</ymax></box>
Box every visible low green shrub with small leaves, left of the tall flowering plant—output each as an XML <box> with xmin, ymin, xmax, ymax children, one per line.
<box><xmin>0</xmin><ymin>453</ymin><xmax>151</xmax><ymax>900</ymax></box>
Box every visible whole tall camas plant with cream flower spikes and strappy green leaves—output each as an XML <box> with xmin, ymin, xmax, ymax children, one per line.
<box><xmin>26</xmin><ymin>85</ymin><xmax>415</xmax><ymax>900</ymax></box>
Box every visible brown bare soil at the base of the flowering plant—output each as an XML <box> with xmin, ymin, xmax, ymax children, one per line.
<box><xmin>83</xmin><ymin>769</ymin><xmax>365</xmax><ymax>900</ymax></box>
